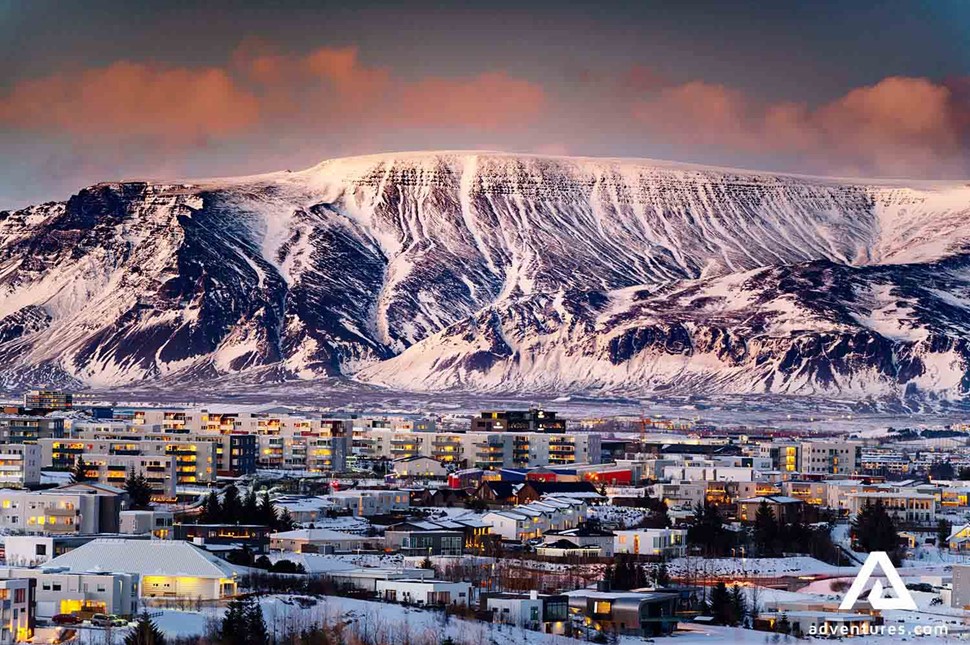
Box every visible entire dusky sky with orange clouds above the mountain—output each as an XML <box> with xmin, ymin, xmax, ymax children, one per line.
<box><xmin>0</xmin><ymin>0</ymin><xmax>970</xmax><ymax>209</ymax></box>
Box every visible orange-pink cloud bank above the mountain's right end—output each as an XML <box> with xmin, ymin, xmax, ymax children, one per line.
<box><xmin>632</xmin><ymin>76</ymin><xmax>968</xmax><ymax>176</ymax></box>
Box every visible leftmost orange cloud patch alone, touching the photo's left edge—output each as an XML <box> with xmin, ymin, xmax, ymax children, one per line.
<box><xmin>0</xmin><ymin>61</ymin><xmax>259</xmax><ymax>140</ymax></box>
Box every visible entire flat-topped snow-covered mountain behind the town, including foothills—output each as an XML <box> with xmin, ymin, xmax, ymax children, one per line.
<box><xmin>0</xmin><ymin>152</ymin><xmax>970</xmax><ymax>400</ymax></box>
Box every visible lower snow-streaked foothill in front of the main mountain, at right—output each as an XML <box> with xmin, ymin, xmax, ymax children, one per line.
<box><xmin>358</xmin><ymin>260</ymin><xmax>970</xmax><ymax>397</ymax></box>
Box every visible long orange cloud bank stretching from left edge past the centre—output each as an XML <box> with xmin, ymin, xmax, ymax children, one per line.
<box><xmin>0</xmin><ymin>41</ymin><xmax>545</xmax><ymax>146</ymax></box>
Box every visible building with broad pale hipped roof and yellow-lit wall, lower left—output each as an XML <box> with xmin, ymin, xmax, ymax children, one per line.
<box><xmin>47</xmin><ymin>538</ymin><xmax>238</xmax><ymax>600</ymax></box>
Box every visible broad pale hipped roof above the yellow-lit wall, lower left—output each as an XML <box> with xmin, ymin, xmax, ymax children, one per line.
<box><xmin>44</xmin><ymin>538</ymin><xmax>240</xmax><ymax>578</ymax></box>
